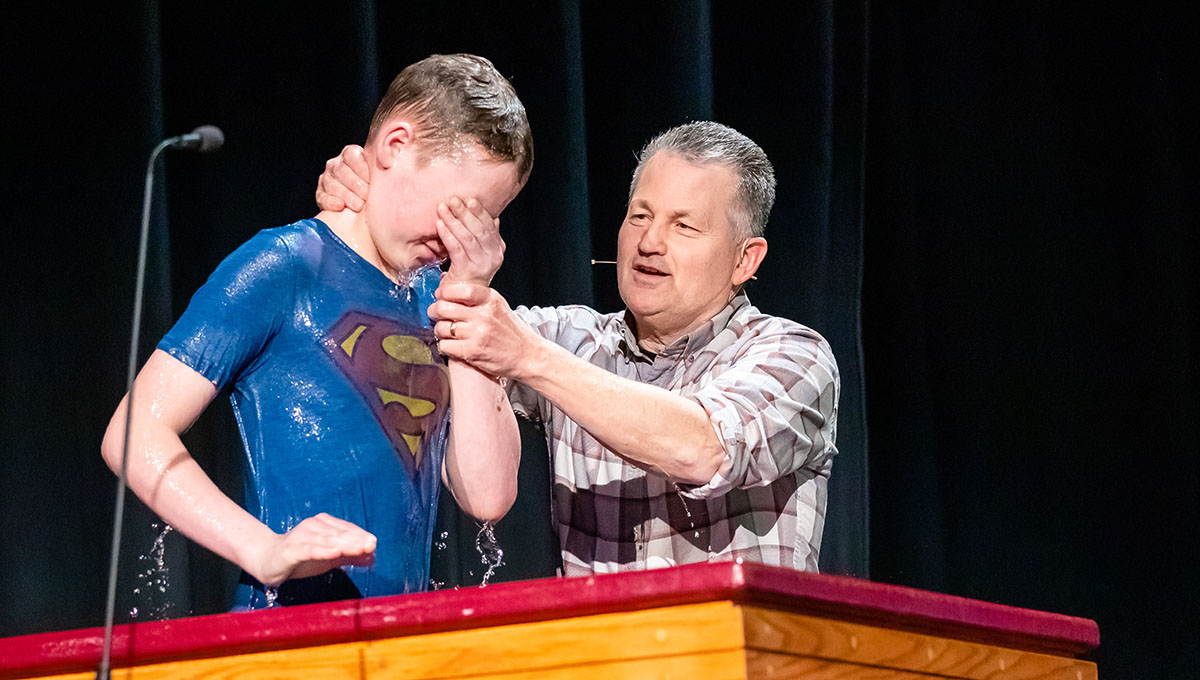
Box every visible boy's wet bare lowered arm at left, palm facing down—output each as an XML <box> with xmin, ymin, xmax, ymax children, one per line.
<box><xmin>101</xmin><ymin>350</ymin><xmax>376</xmax><ymax>585</ymax></box>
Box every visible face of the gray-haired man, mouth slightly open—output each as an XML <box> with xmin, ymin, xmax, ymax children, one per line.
<box><xmin>617</xmin><ymin>151</ymin><xmax>739</xmax><ymax>339</ymax></box>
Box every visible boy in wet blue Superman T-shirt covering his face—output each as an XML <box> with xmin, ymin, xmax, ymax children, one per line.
<box><xmin>102</xmin><ymin>55</ymin><xmax>533</xmax><ymax>608</ymax></box>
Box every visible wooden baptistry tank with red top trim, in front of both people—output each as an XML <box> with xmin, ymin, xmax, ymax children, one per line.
<box><xmin>0</xmin><ymin>562</ymin><xmax>1099</xmax><ymax>680</ymax></box>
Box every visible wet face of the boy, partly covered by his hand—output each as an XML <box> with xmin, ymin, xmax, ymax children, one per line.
<box><xmin>366</xmin><ymin>137</ymin><xmax>521</xmax><ymax>271</ymax></box>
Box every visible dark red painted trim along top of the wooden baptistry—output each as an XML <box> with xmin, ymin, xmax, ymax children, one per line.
<box><xmin>0</xmin><ymin>562</ymin><xmax>1099</xmax><ymax>678</ymax></box>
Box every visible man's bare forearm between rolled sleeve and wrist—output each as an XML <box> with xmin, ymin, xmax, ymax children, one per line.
<box><xmin>518</xmin><ymin>339</ymin><xmax>725</xmax><ymax>483</ymax></box>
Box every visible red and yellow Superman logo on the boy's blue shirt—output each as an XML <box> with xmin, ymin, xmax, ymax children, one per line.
<box><xmin>325</xmin><ymin>312</ymin><xmax>450</xmax><ymax>475</ymax></box>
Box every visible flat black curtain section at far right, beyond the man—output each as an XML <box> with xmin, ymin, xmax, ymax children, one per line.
<box><xmin>863</xmin><ymin>2</ymin><xmax>1200</xmax><ymax>679</ymax></box>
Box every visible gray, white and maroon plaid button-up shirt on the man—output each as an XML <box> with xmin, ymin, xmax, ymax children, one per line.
<box><xmin>509</xmin><ymin>295</ymin><xmax>840</xmax><ymax>576</ymax></box>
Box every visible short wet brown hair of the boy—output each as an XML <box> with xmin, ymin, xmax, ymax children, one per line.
<box><xmin>367</xmin><ymin>54</ymin><xmax>533</xmax><ymax>183</ymax></box>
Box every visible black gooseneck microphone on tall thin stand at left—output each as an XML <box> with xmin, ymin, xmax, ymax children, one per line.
<box><xmin>96</xmin><ymin>125</ymin><xmax>224</xmax><ymax>680</ymax></box>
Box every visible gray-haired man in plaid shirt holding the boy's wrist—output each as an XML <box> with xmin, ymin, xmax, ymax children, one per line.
<box><xmin>318</xmin><ymin>122</ymin><xmax>840</xmax><ymax>576</ymax></box>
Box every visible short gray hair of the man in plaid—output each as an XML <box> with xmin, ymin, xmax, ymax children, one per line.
<box><xmin>629</xmin><ymin>120</ymin><xmax>775</xmax><ymax>241</ymax></box>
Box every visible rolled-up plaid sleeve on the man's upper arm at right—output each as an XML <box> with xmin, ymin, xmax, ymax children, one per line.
<box><xmin>680</xmin><ymin>326</ymin><xmax>840</xmax><ymax>498</ymax></box>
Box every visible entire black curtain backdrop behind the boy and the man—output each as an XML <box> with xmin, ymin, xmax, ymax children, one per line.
<box><xmin>0</xmin><ymin>0</ymin><xmax>1200</xmax><ymax>679</ymax></box>
